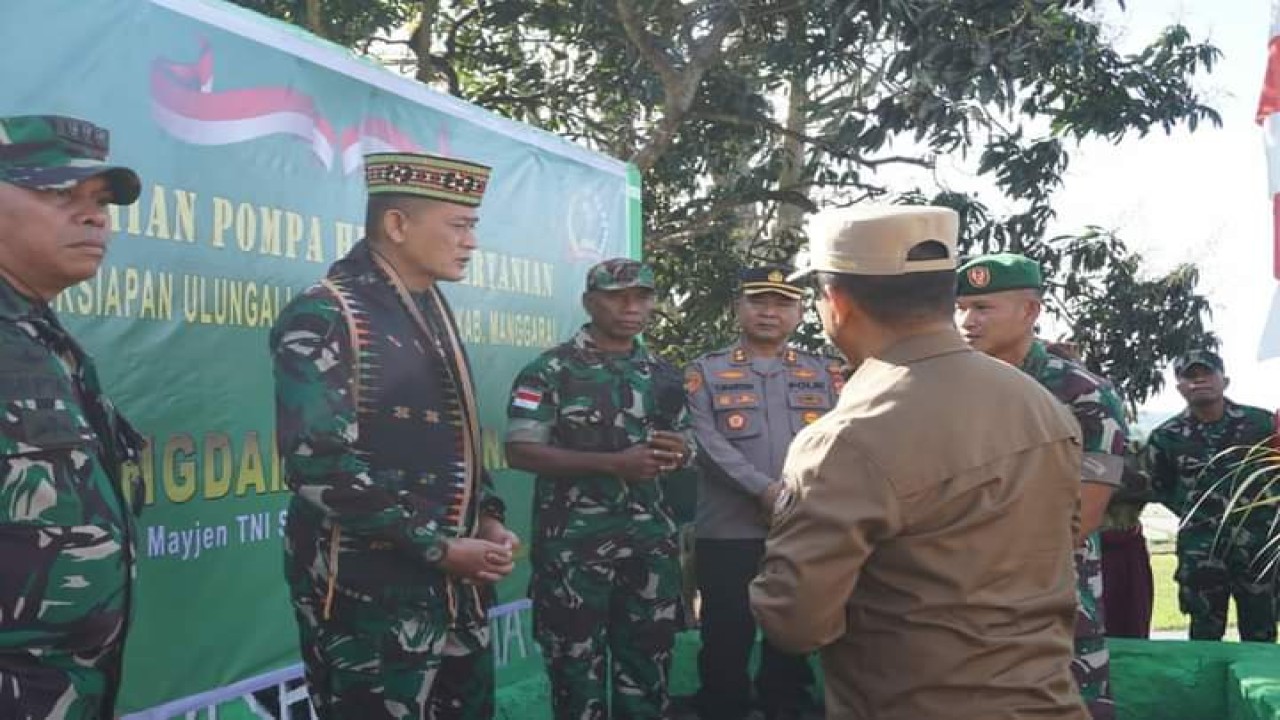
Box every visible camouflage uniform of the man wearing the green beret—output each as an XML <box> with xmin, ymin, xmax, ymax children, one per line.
<box><xmin>1021</xmin><ymin>340</ymin><xmax>1128</xmax><ymax>720</ymax></box>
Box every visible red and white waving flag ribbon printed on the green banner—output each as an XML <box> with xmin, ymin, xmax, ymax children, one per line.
<box><xmin>151</xmin><ymin>40</ymin><xmax>449</xmax><ymax>174</ymax></box>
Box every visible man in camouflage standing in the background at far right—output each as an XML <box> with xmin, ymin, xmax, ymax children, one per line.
<box><xmin>1147</xmin><ymin>350</ymin><xmax>1276</xmax><ymax>642</ymax></box>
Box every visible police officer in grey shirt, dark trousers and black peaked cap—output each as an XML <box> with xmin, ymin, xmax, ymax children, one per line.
<box><xmin>685</xmin><ymin>265</ymin><xmax>845</xmax><ymax>720</ymax></box>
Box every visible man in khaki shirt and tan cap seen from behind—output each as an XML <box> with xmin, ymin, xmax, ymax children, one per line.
<box><xmin>751</xmin><ymin>208</ymin><xmax>1088</xmax><ymax>720</ymax></box>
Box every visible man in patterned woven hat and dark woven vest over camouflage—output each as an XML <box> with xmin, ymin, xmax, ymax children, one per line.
<box><xmin>270</xmin><ymin>148</ymin><xmax>516</xmax><ymax>720</ymax></box>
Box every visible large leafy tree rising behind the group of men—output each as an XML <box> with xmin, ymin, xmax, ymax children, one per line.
<box><xmin>235</xmin><ymin>0</ymin><xmax>1220</xmax><ymax>404</ymax></box>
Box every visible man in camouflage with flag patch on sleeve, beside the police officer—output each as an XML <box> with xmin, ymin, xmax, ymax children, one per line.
<box><xmin>507</xmin><ymin>259</ymin><xmax>692</xmax><ymax>720</ymax></box>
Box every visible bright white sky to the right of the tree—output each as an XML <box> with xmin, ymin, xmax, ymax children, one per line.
<box><xmin>1051</xmin><ymin>0</ymin><xmax>1280</xmax><ymax>416</ymax></box>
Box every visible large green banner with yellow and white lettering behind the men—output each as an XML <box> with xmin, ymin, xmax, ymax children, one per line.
<box><xmin>0</xmin><ymin>0</ymin><xmax>639</xmax><ymax>716</ymax></box>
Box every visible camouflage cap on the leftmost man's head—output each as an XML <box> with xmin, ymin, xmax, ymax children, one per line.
<box><xmin>0</xmin><ymin>115</ymin><xmax>142</xmax><ymax>205</ymax></box>
